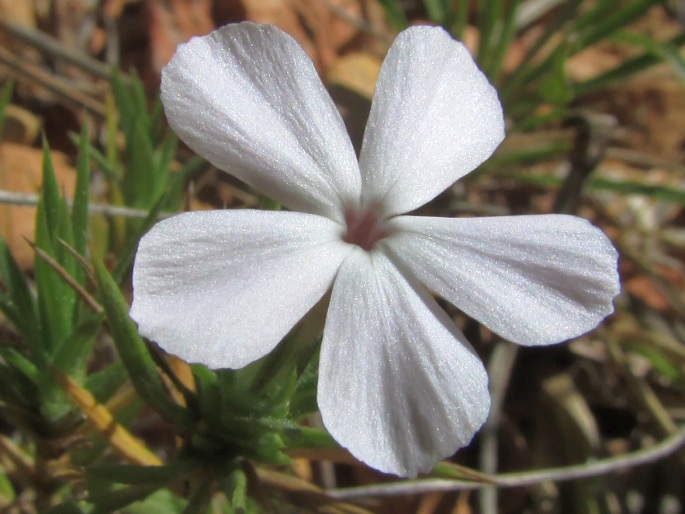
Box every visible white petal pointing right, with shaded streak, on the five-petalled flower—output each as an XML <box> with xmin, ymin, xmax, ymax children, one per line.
<box><xmin>384</xmin><ymin>215</ymin><xmax>619</xmax><ymax>345</ymax></box>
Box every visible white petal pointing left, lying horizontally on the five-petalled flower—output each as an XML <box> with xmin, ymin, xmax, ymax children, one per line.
<box><xmin>131</xmin><ymin>210</ymin><xmax>349</xmax><ymax>368</ymax></box>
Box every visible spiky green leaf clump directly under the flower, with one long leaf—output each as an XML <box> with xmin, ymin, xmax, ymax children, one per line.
<box><xmin>91</xmin><ymin>244</ymin><xmax>337</xmax><ymax>504</ymax></box>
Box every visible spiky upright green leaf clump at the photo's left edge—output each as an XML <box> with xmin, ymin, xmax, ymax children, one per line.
<box><xmin>0</xmin><ymin>131</ymin><xmax>97</xmax><ymax>437</ymax></box>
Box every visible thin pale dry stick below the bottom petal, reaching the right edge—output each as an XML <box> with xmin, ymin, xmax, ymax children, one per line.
<box><xmin>327</xmin><ymin>427</ymin><xmax>685</xmax><ymax>500</ymax></box>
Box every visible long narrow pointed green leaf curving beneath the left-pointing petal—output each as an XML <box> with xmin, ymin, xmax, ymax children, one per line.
<box><xmin>93</xmin><ymin>261</ymin><xmax>193</xmax><ymax>429</ymax></box>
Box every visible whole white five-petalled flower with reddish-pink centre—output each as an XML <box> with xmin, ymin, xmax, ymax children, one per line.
<box><xmin>131</xmin><ymin>23</ymin><xmax>618</xmax><ymax>476</ymax></box>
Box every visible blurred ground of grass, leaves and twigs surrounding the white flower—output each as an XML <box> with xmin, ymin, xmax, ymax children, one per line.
<box><xmin>0</xmin><ymin>0</ymin><xmax>685</xmax><ymax>514</ymax></box>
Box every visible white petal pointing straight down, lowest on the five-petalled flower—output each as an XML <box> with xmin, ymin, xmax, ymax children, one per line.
<box><xmin>318</xmin><ymin>248</ymin><xmax>490</xmax><ymax>476</ymax></box>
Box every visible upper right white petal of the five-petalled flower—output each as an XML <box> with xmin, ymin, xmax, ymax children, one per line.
<box><xmin>360</xmin><ymin>27</ymin><xmax>504</xmax><ymax>216</ymax></box>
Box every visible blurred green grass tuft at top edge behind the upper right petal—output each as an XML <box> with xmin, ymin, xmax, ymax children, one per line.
<box><xmin>380</xmin><ymin>0</ymin><xmax>685</xmax><ymax>126</ymax></box>
